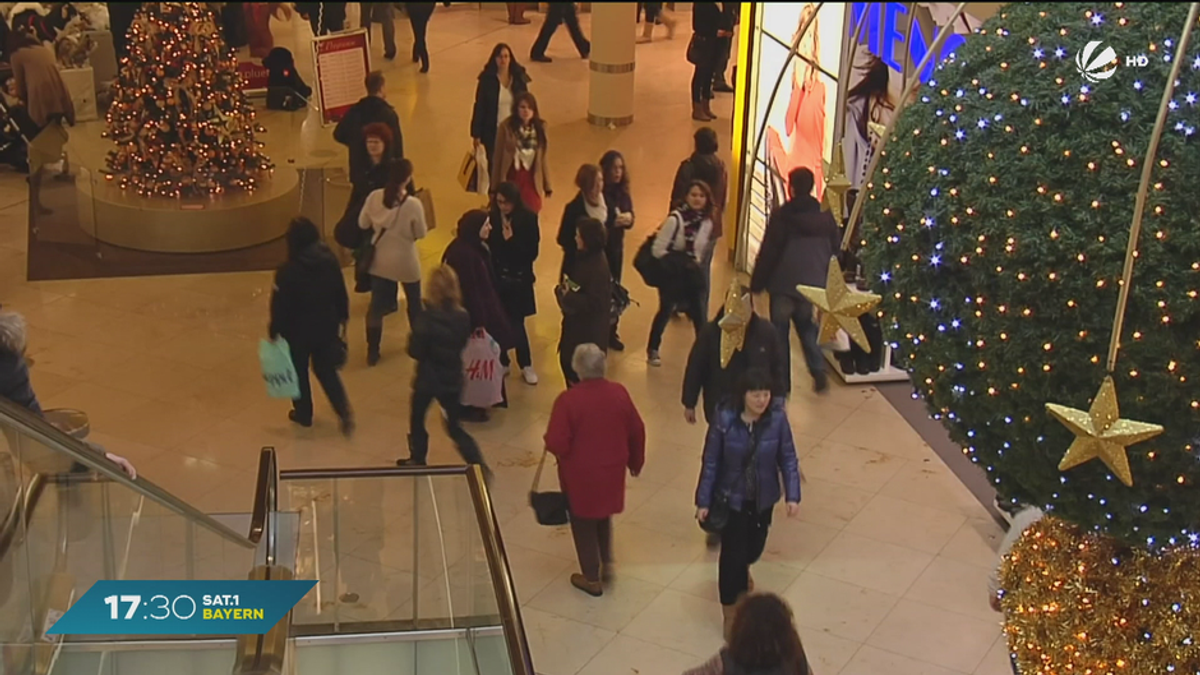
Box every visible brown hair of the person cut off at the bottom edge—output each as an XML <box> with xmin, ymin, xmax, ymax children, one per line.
<box><xmin>728</xmin><ymin>593</ymin><xmax>809</xmax><ymax>675</ymax></box>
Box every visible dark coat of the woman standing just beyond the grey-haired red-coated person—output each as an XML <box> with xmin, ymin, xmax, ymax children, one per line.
<box><xmin>558</xmin><ymin>246</ymin><xmax>612</xmax><ymax>354</ymax></box>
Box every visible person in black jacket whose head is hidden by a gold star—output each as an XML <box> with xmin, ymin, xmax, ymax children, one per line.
<box><xmin>683</xmin><ymin>280</ymin><xmax>787</xmax><ymax>424</ymax></box>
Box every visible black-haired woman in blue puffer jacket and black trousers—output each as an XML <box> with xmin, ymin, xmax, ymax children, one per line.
<box><xmin>696</xmin><ymin>369</ymin><xmax>800</xmax><ymax>634</ymax></box>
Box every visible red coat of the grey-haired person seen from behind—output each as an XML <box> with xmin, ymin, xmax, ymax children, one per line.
<box><xmin>545</xmin><ymin>378</ymin><xmax>646</xmax><ymax>519</ymax></box>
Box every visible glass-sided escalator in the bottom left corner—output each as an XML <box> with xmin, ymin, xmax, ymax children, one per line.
<box><xmin>0</xmin><ymin>401</ymin><xmax>534</xmax><ymax>675</ymax></box>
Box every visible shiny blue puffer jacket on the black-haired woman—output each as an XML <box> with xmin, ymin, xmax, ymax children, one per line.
<box><xmin>696</xmin><ymin>398</ymin><xmax>800</xmax><ymax>512</ymax></box>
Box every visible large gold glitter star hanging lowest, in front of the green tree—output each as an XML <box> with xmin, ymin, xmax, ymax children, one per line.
<box><xmin>1046</xmin><ymin>375</ymin><xmax>1163</xmax><ymax>486</ymax></box>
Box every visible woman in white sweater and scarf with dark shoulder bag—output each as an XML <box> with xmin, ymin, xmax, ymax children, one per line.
<box><xmin>646</xmin><ymin>180</ymin><xmax>714</xmax><ymax>366</ymax></box>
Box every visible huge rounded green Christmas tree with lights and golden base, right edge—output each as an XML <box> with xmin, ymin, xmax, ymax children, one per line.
<box><xmin>860</xmin><ymin>2</ymin><xmax>1200</xmax><ymax>675</ymax></box>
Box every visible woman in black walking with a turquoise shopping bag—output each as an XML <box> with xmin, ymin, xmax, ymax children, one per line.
<box><xmin>268</xmin><ymin>216</ymin><xmax>354</xmax><ymax>437</ymax></box>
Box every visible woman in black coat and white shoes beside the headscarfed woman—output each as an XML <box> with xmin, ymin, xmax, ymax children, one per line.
<box><xmin>487</xmin><ymin>183</ymin><xmax>541</xmax><ymax>384</ymax></box>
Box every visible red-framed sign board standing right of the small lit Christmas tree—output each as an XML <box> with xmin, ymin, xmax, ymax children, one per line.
<box><xmin>312</xmin><ymin>29</ymin><xmax>371</xmax><ymax>125</ymax></box>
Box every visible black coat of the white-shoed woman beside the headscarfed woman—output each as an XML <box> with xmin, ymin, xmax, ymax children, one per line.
<box><xmin>487</xmin><ymin>209</ymin><xmax>541</xmax><ymax>317</ymax></box>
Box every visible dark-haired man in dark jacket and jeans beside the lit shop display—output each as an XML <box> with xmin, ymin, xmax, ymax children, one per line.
<box><xmin>750</xmin><ymin>167</ymin><xmax>841</xmax><ymax>393</ymax></box>
